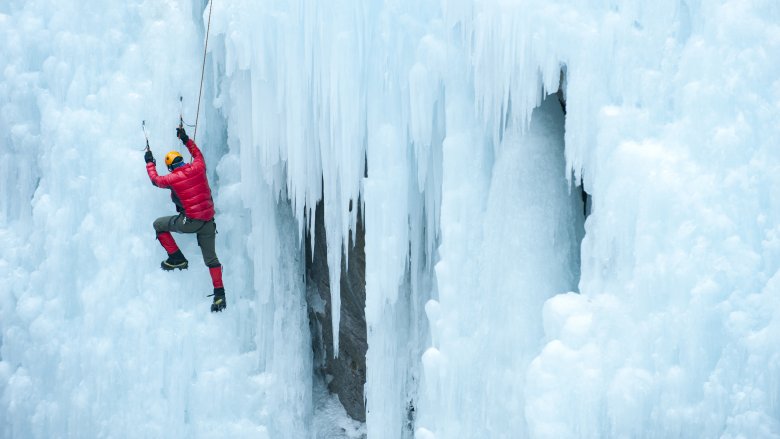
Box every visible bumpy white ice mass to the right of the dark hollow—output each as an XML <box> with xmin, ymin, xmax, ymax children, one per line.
<box><xmin>526</xmin><ymin>2</ymin><xmax>780</xmax><ymax>437</ymax></box>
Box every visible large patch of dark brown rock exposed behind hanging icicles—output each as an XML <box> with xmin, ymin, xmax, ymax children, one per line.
<box><xmin>306</xmin><ymin>203</ymin><xmax>368</xmax><ymax>422</ymax></box>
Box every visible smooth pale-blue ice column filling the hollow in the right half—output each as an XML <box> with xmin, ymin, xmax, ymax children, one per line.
<box><xmin>418</xmin><ymin>94</ymin><xmax>584</xmax><ymax>437</ymax></box>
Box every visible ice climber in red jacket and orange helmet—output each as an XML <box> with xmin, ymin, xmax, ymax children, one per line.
<box><xmin>144</xmin><ymin>127</ymin><xmax>227</xmax><ymax>312</ymax></box>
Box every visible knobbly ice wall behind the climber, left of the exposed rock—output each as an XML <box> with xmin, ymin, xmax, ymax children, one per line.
<box><xmin>0</xmin><ymin>0</ymin><xmax>312</xmax><ymax>438</ymax></box>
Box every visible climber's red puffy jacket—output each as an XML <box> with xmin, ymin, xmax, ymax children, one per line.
<box><xmin>146</xmin><ymin>139</ymin><xmax>214</xmax><ymax>221</ymax></box>
